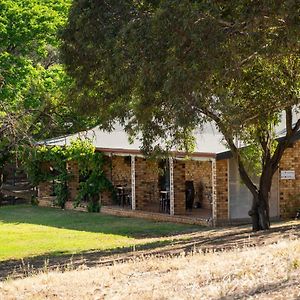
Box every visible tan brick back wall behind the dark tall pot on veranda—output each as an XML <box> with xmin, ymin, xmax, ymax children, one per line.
<box><xmin>185</xmin><ymin>160</ymin><xmax>212</xmax><ymax>209</ymax></box>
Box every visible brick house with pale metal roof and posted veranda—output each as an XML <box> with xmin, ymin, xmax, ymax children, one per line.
<box><xmin>39</xmin><ymin>128</ymin><xmax>300</xmax><ymax>225</ymax></box>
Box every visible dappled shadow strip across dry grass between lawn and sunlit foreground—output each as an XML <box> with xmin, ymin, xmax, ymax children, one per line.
<box><xmin>0</xmin><ymin>219</ymin><xmax>300</xmax><ymax>282</ymax></box>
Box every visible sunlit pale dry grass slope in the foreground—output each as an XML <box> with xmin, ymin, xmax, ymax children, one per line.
<box><xmin>0</xmin><ymin>237</ymin><xmax>300</xmax><ymax>300</ymax></box>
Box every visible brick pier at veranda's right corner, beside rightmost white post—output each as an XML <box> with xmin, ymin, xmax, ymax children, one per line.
<box><xmin>214</xmin><ymin>159</ymin><xmax>228</xmax><ymax>223</ymax></box>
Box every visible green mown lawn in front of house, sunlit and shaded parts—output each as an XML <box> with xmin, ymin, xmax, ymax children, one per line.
<box><xmin>0</xmin><ymin>205</ymin><xmax>202</xmax><ymax>261</ymax></box>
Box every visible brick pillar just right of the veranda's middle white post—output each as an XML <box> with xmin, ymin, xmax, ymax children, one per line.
<box><xmin>173</xmin><ymin>160</ymin><xmax>186</xmax><ymax>215</ymax></box>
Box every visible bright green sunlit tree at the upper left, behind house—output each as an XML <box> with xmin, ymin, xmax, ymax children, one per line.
<box><xmin>0</xmin><ymin>0</ymin><xmax>101</xmax><ymax>173</ymax></box>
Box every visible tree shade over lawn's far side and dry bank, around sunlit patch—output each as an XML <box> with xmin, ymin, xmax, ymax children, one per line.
<box><xmin>0</xmin><ymin>206</ymin><xmax>300</xmax><ymax>280</ymax></box>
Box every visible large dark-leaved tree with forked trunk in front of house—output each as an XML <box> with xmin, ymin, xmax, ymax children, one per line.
<box><xmin>62</xmin><ymin>0</ymin><xmax>300</xmax><ymax>230</ymax></box>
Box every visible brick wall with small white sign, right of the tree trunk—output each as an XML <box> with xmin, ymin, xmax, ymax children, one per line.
<box><xmin>279</xmin><ymin>141</ymin><xmax>300</xmax><ymax>218</ymax></box>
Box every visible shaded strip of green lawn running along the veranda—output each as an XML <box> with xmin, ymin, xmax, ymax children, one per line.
<box><xmin>0</xmin><ymin>205</ymin><xmax>207</xmax><ymax>238</ymax></box>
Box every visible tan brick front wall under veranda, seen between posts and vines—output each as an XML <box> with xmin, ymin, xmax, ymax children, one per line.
<box><xmin>40</xmin><ymin>156</ymin><xmax>218</xmax><ymax>219</ymax></box>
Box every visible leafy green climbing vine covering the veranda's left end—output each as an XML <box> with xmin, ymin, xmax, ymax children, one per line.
<box><xmin>22</xmin><ymin>139</ymin><xmax>115</xmax><ymax>212</ymax></box>
